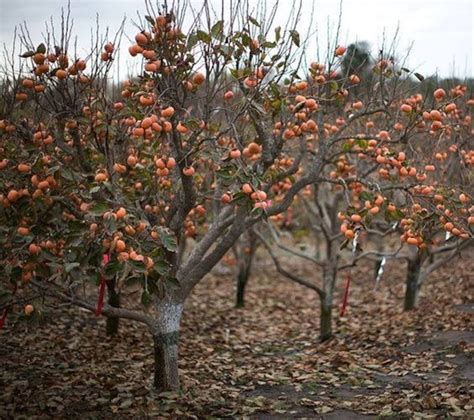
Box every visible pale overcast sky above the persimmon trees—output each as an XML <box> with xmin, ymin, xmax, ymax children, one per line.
<box><xmin>0</xmin><ymin>0</ymin><xmax>474</xmax><ymax>77</ymax></box>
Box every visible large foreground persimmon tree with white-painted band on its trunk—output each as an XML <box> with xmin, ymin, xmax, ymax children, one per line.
<box><xmin>0</xmin><ymin>2</ymin><xmax>330</xmax><ymax>390</ymax></box>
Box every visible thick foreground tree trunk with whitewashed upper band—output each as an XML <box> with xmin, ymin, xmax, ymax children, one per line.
<box><xmin>152</xmin><ymin>302</ymin><xmax>183</xmax><ymax>392</ymax></box>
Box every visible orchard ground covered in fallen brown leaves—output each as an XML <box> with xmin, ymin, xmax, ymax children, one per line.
<box><xmin>0</xmin><ymin>254</ymin><xmax>474</xmax><ymax>419</ymax></box>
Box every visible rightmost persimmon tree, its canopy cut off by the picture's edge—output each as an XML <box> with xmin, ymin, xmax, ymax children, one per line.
<box><xmin>362</xmin><ymin>85</ymin><xmax>474</xmax><ymax>310</ymax></box>
